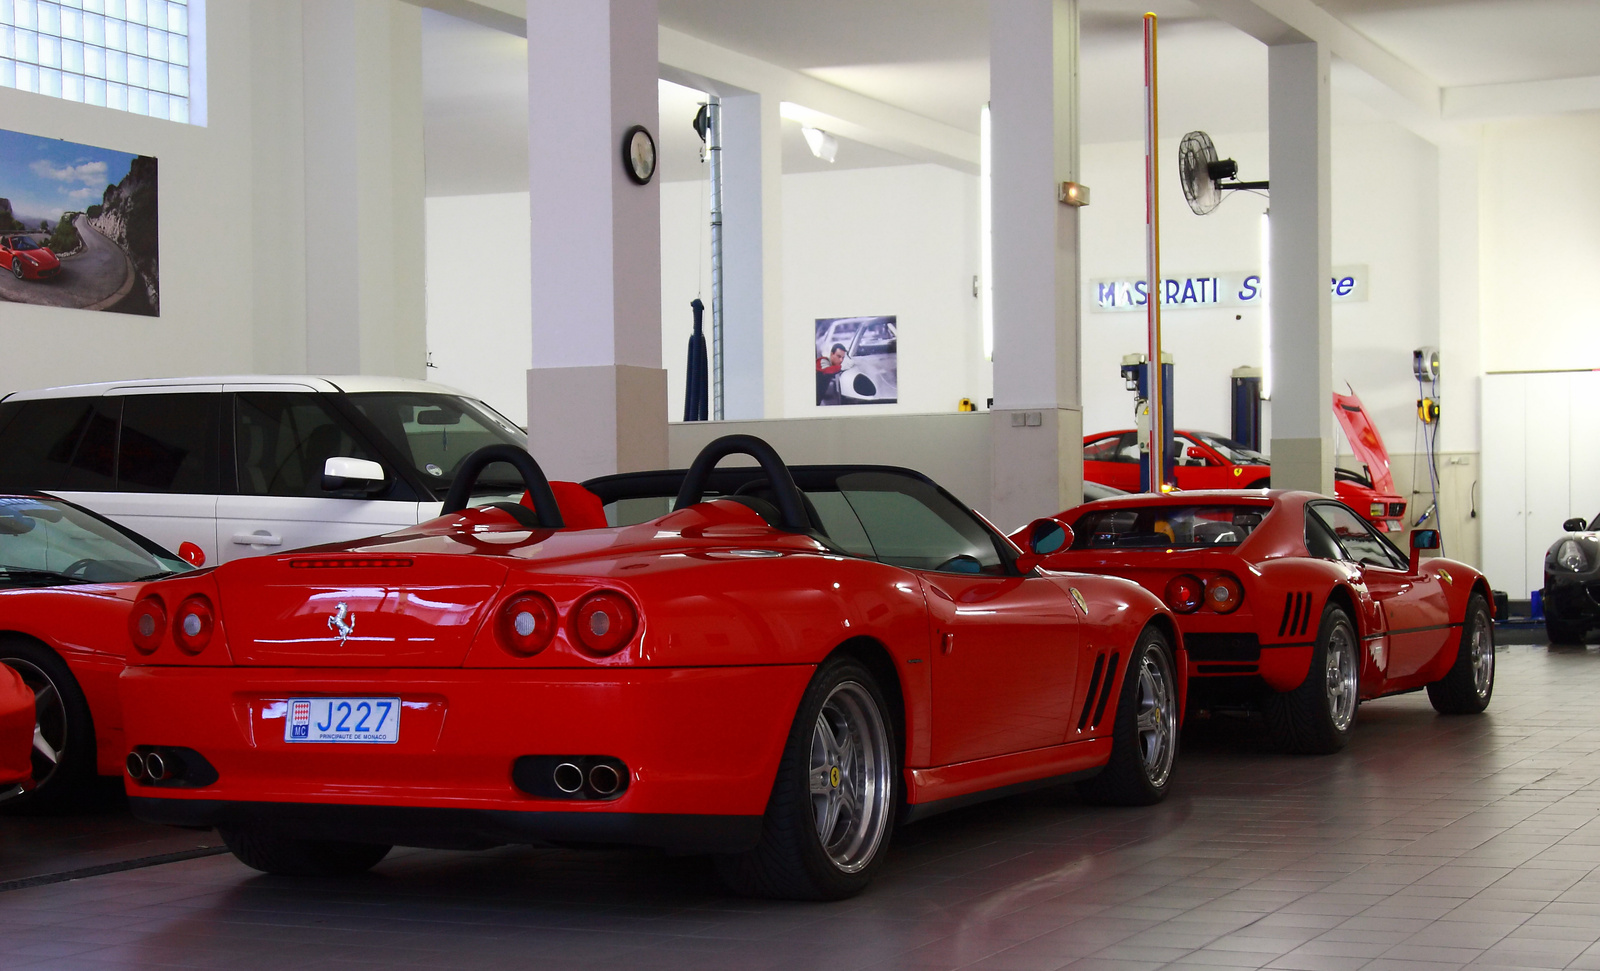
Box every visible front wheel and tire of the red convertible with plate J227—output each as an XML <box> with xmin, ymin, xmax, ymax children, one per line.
<box><xmin>1077</xmin><ymin>627</ymin><xmax>1179</xmax><ymax>806</ymax></box>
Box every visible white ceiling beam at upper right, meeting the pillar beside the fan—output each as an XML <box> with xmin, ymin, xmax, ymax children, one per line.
<box><xmin>1195</xmin><ymin>0</ymin><xmax>1443</xmax><ymax>128</ymax></box>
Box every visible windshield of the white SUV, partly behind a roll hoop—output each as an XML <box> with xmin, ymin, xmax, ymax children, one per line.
<box><xmin>349</xmin><ymin>392</ymin><xmax>528</xmax><ymax>499</ymax></box>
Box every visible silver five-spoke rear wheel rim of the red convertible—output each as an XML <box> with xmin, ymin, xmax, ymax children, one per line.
<box><xmin>811</xmin><ymin>681</ymin><xmax>894</xmax><ymax>873</ymax></box>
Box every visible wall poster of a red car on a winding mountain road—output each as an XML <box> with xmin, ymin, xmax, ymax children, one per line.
<box><xmin>0</xmin><ymin>130</ymin><xmax>162</xmax><ymax>317</ymax></box>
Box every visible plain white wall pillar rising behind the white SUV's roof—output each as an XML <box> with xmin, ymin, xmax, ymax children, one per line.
<box><xmin>299</xmin><ymin>0</ymin><xmax>427</xmax><ymax>378</ymax></box>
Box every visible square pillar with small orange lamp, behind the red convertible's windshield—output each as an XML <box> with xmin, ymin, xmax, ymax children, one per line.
<box><xmin>989</xmin><ymin>0</ymin><xmax>1083</xmax><ymax>529</ymax></box>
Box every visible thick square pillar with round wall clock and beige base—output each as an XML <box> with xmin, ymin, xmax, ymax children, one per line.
<box><xmin>528</xmin><ymin>0</ymin><xmax>667</xmax><ymax>478</ymax></box>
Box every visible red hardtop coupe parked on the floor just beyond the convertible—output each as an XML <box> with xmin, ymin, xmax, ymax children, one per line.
<box><xmin>1058</xmin><ymin>489</ymin><xmax>1494</xmax><ymax>753</ymax></box>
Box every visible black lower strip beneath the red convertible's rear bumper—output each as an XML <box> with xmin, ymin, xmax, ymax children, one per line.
<box><xmin>128</xmin><ymin>797</ymin><xmax>762</xmax><ymax>853</ymax></box>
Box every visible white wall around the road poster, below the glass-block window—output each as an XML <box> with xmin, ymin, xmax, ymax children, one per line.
<box><xmin>0</xmin><ymin>3</ymin><xmax>306</xmax><ymax>394</ymax></box>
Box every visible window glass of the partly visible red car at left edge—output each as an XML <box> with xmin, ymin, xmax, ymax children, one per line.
<box><xmin>0</xmin><ymin>496</ymin><xmax>192</xmax><ymax>587</ymax></box>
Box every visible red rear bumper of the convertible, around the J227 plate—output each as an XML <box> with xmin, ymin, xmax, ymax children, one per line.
<box><xmin>120</xmin><ymin>665</ymin><xmax>813</xmax><ymax>849</ymax></box>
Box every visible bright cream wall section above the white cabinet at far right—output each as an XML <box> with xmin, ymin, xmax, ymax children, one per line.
<box><xmin>1482</xmin><ymin>114</ymin><xmax>1600</xmax><ymax>372</ymax></box>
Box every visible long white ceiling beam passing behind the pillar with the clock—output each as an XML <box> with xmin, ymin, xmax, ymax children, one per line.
<box><xmin>406</xmin><ymin>0</ymin><xmax>979</xmax><ymax>174</ymax></box>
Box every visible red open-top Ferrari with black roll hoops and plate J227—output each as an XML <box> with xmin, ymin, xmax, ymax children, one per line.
<box><xmin>122</xmin><ymin>435</ymin><xmax>1184</xmax><ymax>899</ymax></box>
